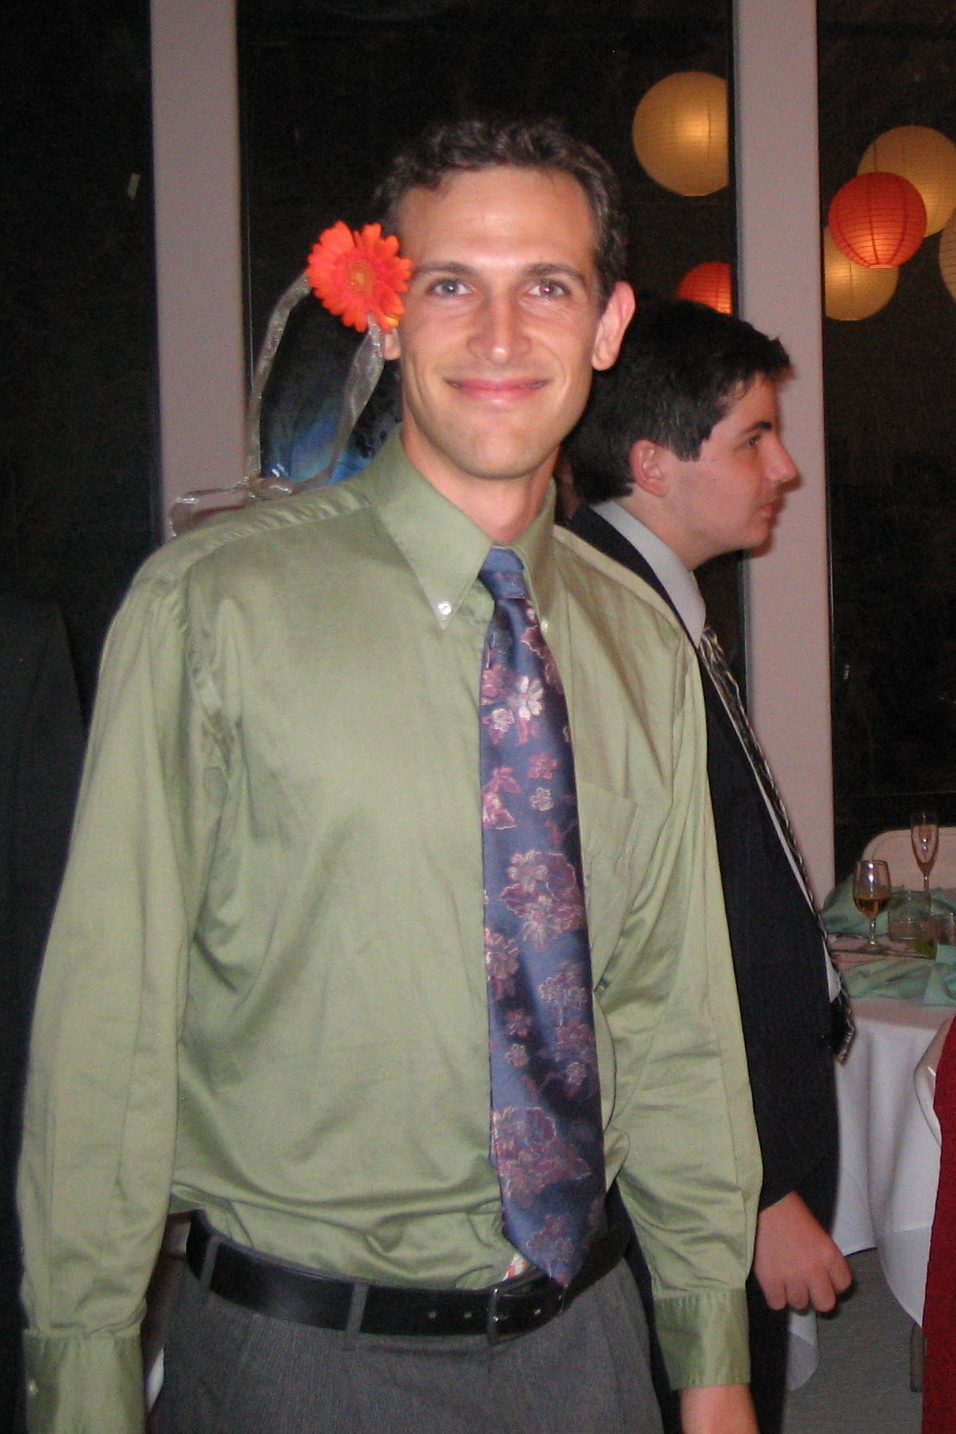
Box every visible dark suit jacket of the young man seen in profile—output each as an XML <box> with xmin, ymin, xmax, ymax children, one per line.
<box><xmin>569</xmin><ymin>505</ymin><xmax>837</xmax><ymax>1225</ymax></box>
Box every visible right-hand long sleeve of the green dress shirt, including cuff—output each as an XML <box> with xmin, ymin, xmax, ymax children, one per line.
<box><xmin>598</xmin><ymin>648</ymin><xmax>761</xmax><ymax>1388</ymax></box>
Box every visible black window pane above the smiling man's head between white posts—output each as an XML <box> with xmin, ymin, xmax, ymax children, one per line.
<box><xmin>239</xmin><ymin>0</ymin><xmax>734</xmax><ymax>347</ymax></box>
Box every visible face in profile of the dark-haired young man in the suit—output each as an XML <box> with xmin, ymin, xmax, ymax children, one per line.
<box><xmin>621</xmin><ymin>376</ymin><xmax>797</xmax><ymax>569</ymax></box>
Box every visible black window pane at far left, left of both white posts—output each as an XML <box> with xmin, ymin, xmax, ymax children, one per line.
<box><xmin>0</xmin><ymin>0</ymin><xmax>158</xmax><ymax>706</ymax></box>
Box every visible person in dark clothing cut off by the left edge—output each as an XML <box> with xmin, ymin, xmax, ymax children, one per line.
<box><xmin>0</xmin><ymin>594</ymin><xmax>83</xmax><ymax>1434</ymax></box>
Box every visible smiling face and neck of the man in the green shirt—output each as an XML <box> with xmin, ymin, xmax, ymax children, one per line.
<box><xmin>386</xmin><ymin>166</ymin><xmax>632</xmax><ymax>531</ymax></box>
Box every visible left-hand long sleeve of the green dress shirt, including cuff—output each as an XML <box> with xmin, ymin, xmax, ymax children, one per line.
<box><xmin>19</xmin><ymin>575</ymin><xmax>222</xmax><ymax>1434</ymax></box>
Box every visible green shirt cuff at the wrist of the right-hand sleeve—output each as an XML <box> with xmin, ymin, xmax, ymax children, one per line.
<box><xmin>654</xmin><ymin>1289</ymin><xmax>750</xmax><ymax>1390</ymax></box>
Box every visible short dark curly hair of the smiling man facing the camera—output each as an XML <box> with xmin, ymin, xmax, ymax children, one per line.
<box><xmin>373</xmin><ymin>118</ymin><xmax>628</xmax><ymax>304</ymax></box>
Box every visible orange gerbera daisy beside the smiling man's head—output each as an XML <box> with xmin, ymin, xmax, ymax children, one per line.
<box><xmin>307</xmin><ymin>219</ymin><xmax>411</xmax><ymax>334</ymax></box>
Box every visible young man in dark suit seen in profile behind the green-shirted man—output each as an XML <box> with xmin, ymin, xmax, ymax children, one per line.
<box><xmin>566</xmin><ymin>301</ymin><xmax>851</xmax><ymax>1434</ymax></box>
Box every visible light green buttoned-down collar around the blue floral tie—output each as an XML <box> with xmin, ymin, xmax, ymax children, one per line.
<box><xmin>366</xmin><ymin>430</ymin><xmax>555</xmax><ymax>628</ymax></box>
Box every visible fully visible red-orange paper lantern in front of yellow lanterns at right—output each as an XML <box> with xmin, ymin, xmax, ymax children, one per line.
<box><xmin>828</xmin><ymin>169</ymin><xmax>926</xmax><ymax>268</ymax></box>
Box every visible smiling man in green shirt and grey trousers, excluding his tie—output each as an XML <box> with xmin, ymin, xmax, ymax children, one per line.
<box><xmin>20</xmin><ymin>123</ymin><xmax>760</xmax><ymax>1434</ymax></box>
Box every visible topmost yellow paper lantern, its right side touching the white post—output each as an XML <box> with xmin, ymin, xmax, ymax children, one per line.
<box><xmin>631</xmin><ymin>70</ymin><xmax>728</xmax><ymax>195</ymax></box>
